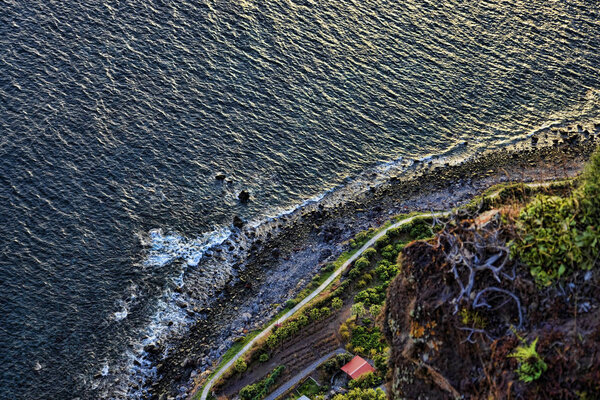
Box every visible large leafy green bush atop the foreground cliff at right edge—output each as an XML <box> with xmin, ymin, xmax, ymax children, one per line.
<box><xmin>511</xmin><ymin>148</ymin><xmax>600</xmax><ymax>286</ymax></box>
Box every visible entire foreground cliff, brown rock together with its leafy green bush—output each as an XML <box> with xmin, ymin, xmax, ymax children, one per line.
<box><xmin>384</xmin><ymin>149</ymin><xmax>600</xmax><ymax>399</ymax></box>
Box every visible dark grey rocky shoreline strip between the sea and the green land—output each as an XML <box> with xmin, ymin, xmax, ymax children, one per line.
<box><xmin>125</xmin><ymin>124</ymin><xmax>600</xmax><ymax>399</ymax></box>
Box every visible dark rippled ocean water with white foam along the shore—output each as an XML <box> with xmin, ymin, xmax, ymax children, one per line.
<box><xmin>0</xmin><ymin>0</ymin><xmax>600</xmax><ymax>399</ymax></box>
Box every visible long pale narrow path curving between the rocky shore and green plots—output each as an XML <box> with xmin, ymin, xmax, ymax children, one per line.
<box><xmin>200</xmin><ymin>211</ymin><xmax>450</xmax><ymax>400</ymax></box>
